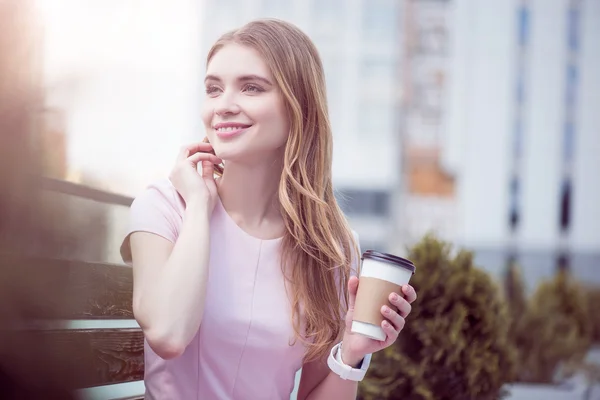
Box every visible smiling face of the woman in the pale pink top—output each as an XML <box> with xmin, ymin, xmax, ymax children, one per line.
<box><xmin>202</xmin><ymin>43</ymin><xmax>290</xmax><ymax>163</ymax></box>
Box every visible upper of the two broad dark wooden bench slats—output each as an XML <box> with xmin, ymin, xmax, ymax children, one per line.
<box><xmin>0</xmin><ymin>254</ymin><xmax>133</xmax><ymax>319</ymax></box>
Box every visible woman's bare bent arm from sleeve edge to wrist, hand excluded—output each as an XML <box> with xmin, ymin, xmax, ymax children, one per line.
<box><xmin>131</xmin><ymin>200</ymin><xmax>210</xmax><ymax>359</ymax></box>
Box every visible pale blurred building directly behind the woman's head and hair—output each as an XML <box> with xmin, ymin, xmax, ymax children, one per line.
<box><xmin>201</xmin><ymin>0</ymin><xmax>403</xmax><ymax>249</ymax></box>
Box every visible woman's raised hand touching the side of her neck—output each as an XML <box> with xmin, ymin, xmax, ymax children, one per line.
<box><xmin>169</xmin><ymin>143</ymin><xmax>221</xmax><ymax>214</ymax></box>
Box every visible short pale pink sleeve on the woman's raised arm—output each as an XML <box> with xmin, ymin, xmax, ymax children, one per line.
<box><xmin>120</xmin><ymin>180</ymin><xmax>184</xmax><ymax>264</ymax></box>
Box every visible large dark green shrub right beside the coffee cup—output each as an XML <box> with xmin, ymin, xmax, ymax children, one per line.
<box><xmin>359</xmin><ymin>235</ymin><xmax>515</xmax><ymax>400</ymax></box>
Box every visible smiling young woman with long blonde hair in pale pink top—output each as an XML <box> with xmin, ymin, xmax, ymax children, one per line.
<box><xmin>122</xmin><ymin>20</ymin><xmax>416</xmax><ymax>400</ymax></box>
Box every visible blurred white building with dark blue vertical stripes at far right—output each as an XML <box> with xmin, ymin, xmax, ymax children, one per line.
<box><xmin>442</xmin><ymin>0</ymin><xmax>600</xmax><ymax>287</ymax></box>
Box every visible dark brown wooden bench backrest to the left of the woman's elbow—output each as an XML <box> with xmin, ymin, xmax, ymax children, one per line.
<box><xmin>0</xmin><ymin>178</ymin><xmax>144</xmax><ymax>399</ymax></box>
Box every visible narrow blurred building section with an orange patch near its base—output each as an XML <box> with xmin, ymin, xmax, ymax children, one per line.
<box><xmin>396</xmin><ymin>0</ymin><xmax>457</xmax><ymax>251</ymax></box>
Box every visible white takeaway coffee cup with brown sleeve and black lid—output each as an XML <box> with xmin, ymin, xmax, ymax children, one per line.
<box><xmin>352</xmin><ymin>250</ymin><xmax>415</xmax><ymax>340</ymax></box>
